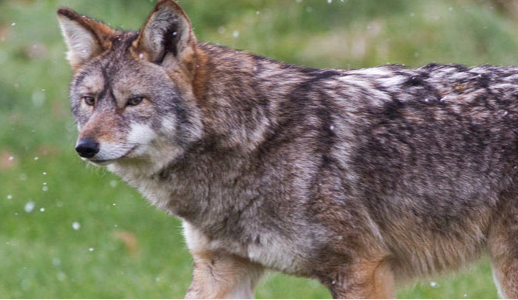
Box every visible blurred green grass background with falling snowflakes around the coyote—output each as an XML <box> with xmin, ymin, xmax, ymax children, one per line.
<box><xmin>0</xmin><ymin>0</ymin><xmax>518</xmax><ymax>298</ymax></box>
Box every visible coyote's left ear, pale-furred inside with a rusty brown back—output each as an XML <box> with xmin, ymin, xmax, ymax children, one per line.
<box><xmin>58</xmin><ymin>8</ymin><xmax>115</xmax><ymax>70</ymax></box>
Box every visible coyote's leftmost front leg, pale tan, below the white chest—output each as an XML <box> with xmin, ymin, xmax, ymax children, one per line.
<box><xmin>185</xmin><ymin>252</ymin><xmax>263</xmax><ymax>298</ymax></box>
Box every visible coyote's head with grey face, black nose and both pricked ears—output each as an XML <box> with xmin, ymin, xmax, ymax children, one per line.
<box><xmin>58</xmin><ymin>0</ymin><xmax>201</xmax><ymax>169</ymax></box>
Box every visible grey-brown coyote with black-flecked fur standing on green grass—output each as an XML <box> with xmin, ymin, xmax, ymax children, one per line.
<box><xmin>58</xmin><ymin>0</ymin><xmax>518</xmax><ymax>298</ymax></box>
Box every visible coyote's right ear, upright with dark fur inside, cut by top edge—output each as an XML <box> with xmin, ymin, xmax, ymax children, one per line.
<box><xmin>135</xmin><ymin>0</ymin><xmax>196</xmax><ymax>68</ymax></box>
